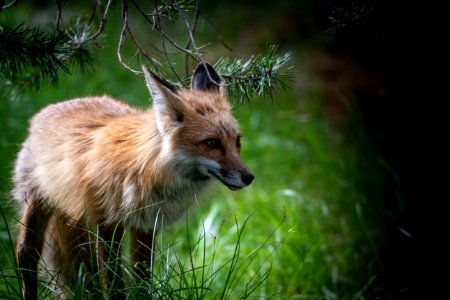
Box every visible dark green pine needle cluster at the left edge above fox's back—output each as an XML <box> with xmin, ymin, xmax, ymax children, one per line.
<box><xmin>0</xmin><ymin>22</ymin><xmax>94</xmax><ymax>88</ymax></box>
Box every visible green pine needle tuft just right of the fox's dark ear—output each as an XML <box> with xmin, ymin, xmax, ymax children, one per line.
<box><xmin>215</xmin><ymin>45</ymin><xmax>293</xmax><ymax>102</ymax></box>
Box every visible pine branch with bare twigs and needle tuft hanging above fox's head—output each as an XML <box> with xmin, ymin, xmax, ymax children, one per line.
<box><xmin>128</xmin><ymin>0</ymin><xmax>292</xmax><ymax>102</ymax></box>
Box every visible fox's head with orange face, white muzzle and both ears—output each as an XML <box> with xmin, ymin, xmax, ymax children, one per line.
<box><xmin>142</xmin><ymin>63</ymin><xmax>254</xmax><ymax>190</ymax></box>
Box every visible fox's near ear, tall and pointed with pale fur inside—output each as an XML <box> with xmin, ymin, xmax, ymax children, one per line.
<box><xmin>142</xmin><ymin>65</ymin><xmax>185</xmax><ymax>133</ymax></box>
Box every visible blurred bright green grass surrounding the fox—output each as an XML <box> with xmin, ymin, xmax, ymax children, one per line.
<box><xmin>0</xmin><ymin>2</ymin><xmax>384</xmax><ymax>299</ymax></box>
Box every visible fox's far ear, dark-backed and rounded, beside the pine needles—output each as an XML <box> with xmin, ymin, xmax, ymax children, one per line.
<box><xmin>191</xmin><ymin>62</ymin><xmax>222</xmax><ymax>93</ymax></box>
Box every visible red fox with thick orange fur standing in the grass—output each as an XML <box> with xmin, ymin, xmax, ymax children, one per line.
<box><xmin>13</xmin><ymin>63</ymin><xmax>254</xmax><ymax>299</ymax></box>
